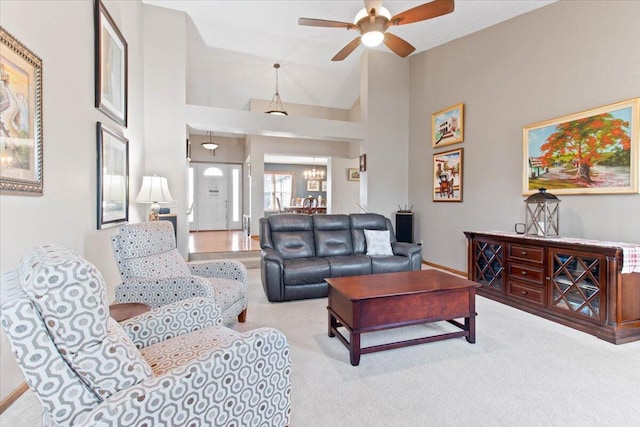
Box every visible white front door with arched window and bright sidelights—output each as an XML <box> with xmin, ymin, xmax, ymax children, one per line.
<box><xmin>188</xmin><ymin>162</ymin><xmax>242</xmax><ymax>231</ymax></box>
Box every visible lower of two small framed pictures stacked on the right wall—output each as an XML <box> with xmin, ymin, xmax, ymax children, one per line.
<box><xmin>433</xmin><ymin>148</ymin><xmax>463</xmax><ymax>202</ymax></box>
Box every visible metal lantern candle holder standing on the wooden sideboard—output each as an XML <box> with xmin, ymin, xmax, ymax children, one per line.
<box><xmin>524</xmin><ymin>188</ymin><xmax>560</xmax><ymax>237</ymax></box>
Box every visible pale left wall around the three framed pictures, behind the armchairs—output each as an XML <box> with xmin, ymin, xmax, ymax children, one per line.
<box><xmin>0</xmin><ymin>1</ymin><xmax>145</xmax><ymax>399</ymax></box>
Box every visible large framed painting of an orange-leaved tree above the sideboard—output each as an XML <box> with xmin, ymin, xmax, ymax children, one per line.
<box><xmin>522</xmin><ymin>98</ymin><xmax>640</xmax><ymax>195</ymax></box>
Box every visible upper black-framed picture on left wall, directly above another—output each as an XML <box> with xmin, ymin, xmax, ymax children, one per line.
<box><xmin>94</xmin><ymin>0</ymin><xmax>129</xmax><ymax>127</ymax></box>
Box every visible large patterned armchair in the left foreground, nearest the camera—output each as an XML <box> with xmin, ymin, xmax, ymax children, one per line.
<box><xmin>0</xmin><ymin>246</ymin><xmax>291</xmax><ymax>427</ymax></box>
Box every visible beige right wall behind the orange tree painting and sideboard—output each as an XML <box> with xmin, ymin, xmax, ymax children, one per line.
<box><xmin>409</xmin><ymin>1</ymin><xmax>640</xmax><ymax>271</ymax></box>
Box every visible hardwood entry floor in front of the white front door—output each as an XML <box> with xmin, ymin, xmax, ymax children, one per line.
<box><xmin>189</xmin><ymin>230</ymin><xmax>260</xmax><ymax>253</ymax></box>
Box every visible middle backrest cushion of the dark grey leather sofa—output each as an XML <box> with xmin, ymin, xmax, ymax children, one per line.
<box><xmin>313</xmin><ymin>215</ymin><xmax>353</xmax><ymax>257</ymax></box>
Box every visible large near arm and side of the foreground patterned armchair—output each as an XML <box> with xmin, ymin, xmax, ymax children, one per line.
<box><xmin>75</xmin><ymin>328</ymin><xmax>291</xmax><ymax>427</ymax></box>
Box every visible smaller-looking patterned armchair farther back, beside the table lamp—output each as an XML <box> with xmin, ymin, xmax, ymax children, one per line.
<box><xmin>111</xmin><ymin>221</ymin><xmax>247</xmax><ymax>325</ymax></box>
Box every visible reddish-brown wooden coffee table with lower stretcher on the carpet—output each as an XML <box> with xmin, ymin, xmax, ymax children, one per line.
<box><xmin>326</xmin><ymin>270</ymin><xmax>478</xmax><ymax>366</ymax></box>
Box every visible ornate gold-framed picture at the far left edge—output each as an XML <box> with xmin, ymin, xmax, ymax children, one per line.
<box><xmin>0</xmin><ymin>27</ymin><xmax>43</xmax><ymax>196</ymax></box>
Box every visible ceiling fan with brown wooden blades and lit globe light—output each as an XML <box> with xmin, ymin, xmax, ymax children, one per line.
<box><xmin>298</xmin><ymin>0</ymin><xmax>454</xmax><ymax>61</ymax></box>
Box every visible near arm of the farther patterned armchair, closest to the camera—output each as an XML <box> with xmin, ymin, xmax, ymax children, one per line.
<box><xmin>116</xmin><ymin>276</ymin><xmax>215</xmax><ymax>308</ymax></box>
